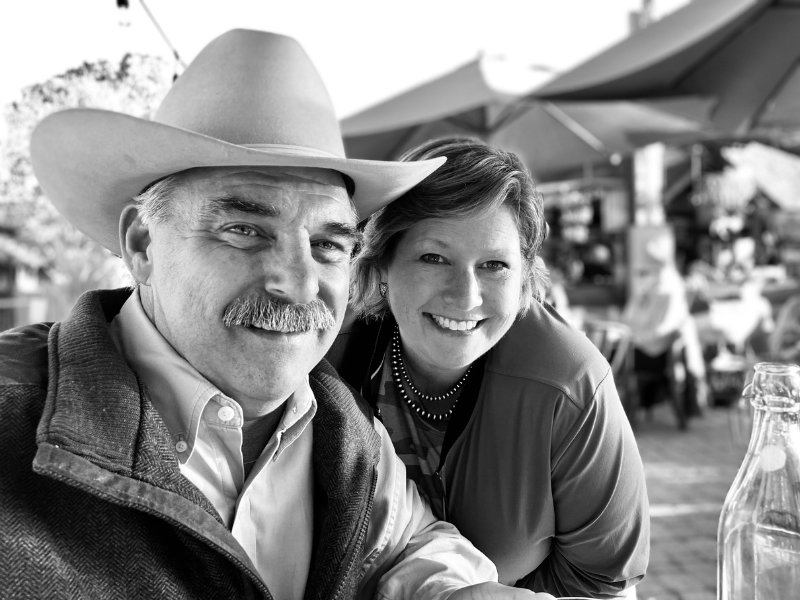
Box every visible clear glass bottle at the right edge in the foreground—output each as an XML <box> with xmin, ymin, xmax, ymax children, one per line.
<box><xmin>717</xmin><ymin>363</ymin><xmax>800</xmax><ymax>600</ymax></box>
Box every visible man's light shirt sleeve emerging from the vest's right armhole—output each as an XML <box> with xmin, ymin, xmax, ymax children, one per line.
<box><xmin>358</xmin><ymin>421</ymin><xmax>497</xmax><ymax>600</ymax></box>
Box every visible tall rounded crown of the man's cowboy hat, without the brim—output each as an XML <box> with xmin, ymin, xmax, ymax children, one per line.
<box><xmin>154</xmin><ymin>29</ymin><xmax>345</xmax><ymax>157</ymax></box>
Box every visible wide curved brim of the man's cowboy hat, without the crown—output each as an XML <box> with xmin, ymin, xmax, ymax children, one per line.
<box><xmin>31</xmin><ymin>108</ymin><xmax>444</xmax><ymax>254</ymax></box>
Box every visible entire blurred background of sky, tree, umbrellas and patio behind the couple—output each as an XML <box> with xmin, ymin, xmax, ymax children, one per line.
<box><xmin>0</xmin><ymin>0</ymin><xmax>800</xmax><ymax>599</ymax></box>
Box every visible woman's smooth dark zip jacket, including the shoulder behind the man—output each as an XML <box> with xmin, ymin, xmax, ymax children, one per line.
<box><xmin>329</xmin><ymin>303</ymin><xmax>650</xmax><ymax>598</ymax></box>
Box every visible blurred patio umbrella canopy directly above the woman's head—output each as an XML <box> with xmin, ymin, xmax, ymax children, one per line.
<box><xmin>341</xmin><ymin>59</ymin><xmax>701</xmax><ymax>179</ymax></box>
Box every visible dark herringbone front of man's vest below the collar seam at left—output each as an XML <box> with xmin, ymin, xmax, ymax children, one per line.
<box><xmin>0</xmin><ymin>385</ymin><xmax>244</xmax><ymax>600</ymax></box>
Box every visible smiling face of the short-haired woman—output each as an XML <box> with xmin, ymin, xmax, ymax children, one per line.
<box><xmin>381</xmin><ymin>206</ymin><xmax>523</xmax><ymax>376</ymax></box>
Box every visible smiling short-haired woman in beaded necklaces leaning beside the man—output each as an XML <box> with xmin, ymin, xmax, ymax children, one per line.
<box><xmin>332</xmin><ymin>139</ymin><xmax>649</xmax><ymax>598</ymax></box>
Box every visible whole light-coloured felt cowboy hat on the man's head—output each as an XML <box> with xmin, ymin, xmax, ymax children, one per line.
<box><xmin>31</xmin><ymin>29</ymin><xmax>444</xmax><ymax>254</ymax></box>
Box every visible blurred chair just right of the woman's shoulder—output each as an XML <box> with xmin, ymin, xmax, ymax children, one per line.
<box><xmin>583</xmin><ymin>319</ymin><xmax>639</xmax><ymax>427</ymax></box>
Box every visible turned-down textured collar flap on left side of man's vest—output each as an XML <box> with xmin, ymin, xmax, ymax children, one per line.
<box><xmin>36</xmin><ymin>289</ymin><xmax>221</xmax><ymax>522</ymax></box>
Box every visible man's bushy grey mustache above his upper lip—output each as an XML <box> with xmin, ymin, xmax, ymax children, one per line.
<box><xmin>222</xmin><ymin>295</ymin><xmax>336</xmax><ymax>333</ymax></box>
